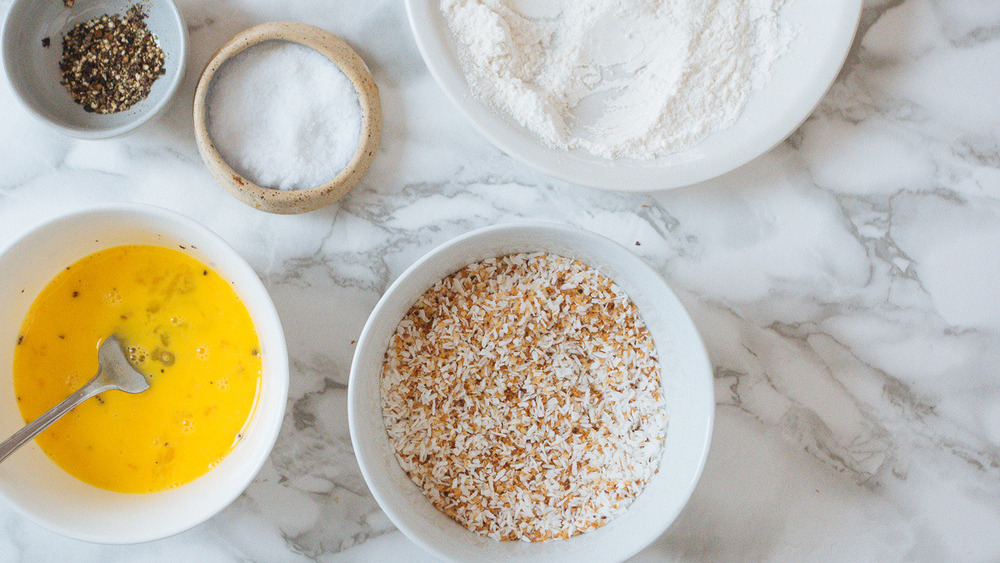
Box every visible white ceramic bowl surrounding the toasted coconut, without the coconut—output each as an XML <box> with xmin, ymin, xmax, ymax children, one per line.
<box><xmin>347</xmin><ymin>223</ymin><xmax>715</xmax><ymax>562</ymax></box>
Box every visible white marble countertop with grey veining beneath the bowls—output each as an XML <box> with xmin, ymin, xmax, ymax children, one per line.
<box><xmin>0</xmin><ymin>0</ymin><xmax>1000</xmax><ymax>561</ymax></box>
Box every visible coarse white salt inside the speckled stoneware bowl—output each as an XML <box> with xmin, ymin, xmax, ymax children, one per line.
<box><xmin>206</xmin><ymin>40</ymin><xmax>361</xmax><ymax>190</ymax></box>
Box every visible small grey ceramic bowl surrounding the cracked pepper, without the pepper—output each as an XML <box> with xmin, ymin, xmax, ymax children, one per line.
<box><xmin>2</xmin><ymin>0</ymin><xmax>187</xmax><ymax>139</ymax></box>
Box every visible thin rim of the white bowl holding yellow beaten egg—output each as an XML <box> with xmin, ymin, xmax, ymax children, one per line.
<box><xmin>0</xmin><ymin>203</ymin><xmax>290</xmax><ymax>545</ymax></box>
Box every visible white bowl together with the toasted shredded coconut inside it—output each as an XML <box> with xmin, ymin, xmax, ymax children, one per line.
<box><xmin>348</xmin><ymin>223</ymin><xmax>715</xmax><ymax>562</ymax></box>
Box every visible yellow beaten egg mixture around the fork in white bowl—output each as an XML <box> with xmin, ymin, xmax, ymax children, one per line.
<box><xmin>14</xmin><ymin>245</ymin><xmax>261</xmax><ymax>493</ymax></box>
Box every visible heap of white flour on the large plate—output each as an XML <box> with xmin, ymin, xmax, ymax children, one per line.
<box><xmin>441</xmin><ymin>0</ymin><xmax>792</xmax><ymax>159</ymax></box>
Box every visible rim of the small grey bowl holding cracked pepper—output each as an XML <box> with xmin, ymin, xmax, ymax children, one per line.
<box><xmin>0</xmin><ymin>0</ymin><xmax>190</xmax><ymax>140</ymax></box>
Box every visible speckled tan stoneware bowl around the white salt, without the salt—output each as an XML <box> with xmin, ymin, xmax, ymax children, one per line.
<box><xmin>194</xmin><ymin>22</ymin><xmax>382</xmax><ymax>213</ymax></box>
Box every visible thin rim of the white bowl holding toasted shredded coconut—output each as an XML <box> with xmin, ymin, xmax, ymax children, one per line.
<box><xmin>347</xmin><ymin>220</ymin><xmax>715</xmax><ymax>561</ymax></box>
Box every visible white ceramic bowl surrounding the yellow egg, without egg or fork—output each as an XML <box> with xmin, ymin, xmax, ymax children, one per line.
<box><xmin>0</xmin><ymin>204</ymin><xmax>288</xmax><ymax>543</ymax></box>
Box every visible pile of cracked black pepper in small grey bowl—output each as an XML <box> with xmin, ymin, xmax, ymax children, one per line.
<box><xmin>59</xmin><ymin>5</ymin><xmax>166</xmax><ymax>113</ymax></box>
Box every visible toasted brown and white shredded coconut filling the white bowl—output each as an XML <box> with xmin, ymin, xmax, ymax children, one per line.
<box><xmin>381</xmin><ymin>253</ymin><xmax>667</xmax><ymax>541</ymax></box>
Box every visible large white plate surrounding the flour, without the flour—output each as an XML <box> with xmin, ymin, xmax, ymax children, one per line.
<box><xmin>406</xmin><ymin>0</ymin><xmax>862</xmax><ymax>191</ymax></box>
